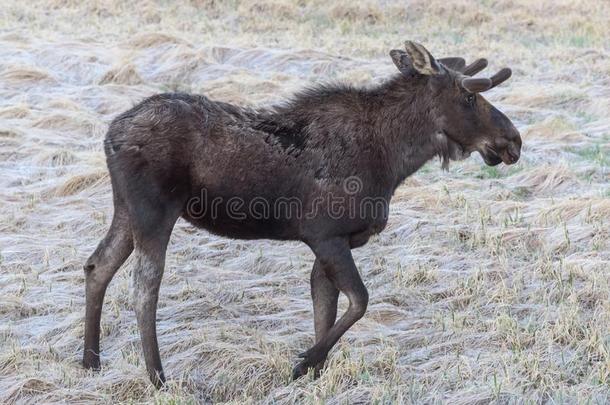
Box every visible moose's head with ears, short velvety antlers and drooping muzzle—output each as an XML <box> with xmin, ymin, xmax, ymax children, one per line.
<box><xmin>390</xmin><ymin>41</ymin><xmax>521</xmax><ymax>166</ymax></box>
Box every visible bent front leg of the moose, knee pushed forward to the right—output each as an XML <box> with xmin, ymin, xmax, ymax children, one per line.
<box><xmin>292</xmin><ymin>238</ymin><xmax>369</xmax><ymax>379</ymax></box>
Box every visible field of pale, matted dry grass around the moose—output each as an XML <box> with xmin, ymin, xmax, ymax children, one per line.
<box><xmin>0</xmin><ymin>0</ymin><xmax>610</xmax><ymax>404</ymax></box>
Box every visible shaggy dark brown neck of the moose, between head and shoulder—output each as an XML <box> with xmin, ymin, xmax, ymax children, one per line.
<box><xmin>372</xmin><ymin>75</ymin><xmax>448</xmax><ymax>188</ymax></box>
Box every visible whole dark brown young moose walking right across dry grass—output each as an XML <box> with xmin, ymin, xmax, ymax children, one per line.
<box><xmin>83</xmin><ymin>41</ymin><xmax>521</xmax><ymax>386</ymax></box>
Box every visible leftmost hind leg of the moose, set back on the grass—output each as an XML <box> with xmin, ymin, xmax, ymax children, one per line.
<box><xmin>83</xmin><ymin>200</ymin><xmax>133</xmax><ymax>369</ymax></box>
